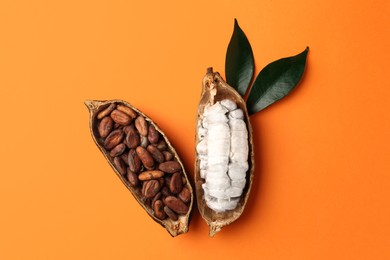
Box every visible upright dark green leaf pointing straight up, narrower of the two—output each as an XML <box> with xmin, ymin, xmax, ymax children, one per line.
<box><xmin>225</xmin><ymin>19</ymin><xmax>254</xmax><ymax>96</ymax></box>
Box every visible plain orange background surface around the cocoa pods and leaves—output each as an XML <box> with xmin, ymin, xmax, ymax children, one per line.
<box><xmin>0</xmin><ymin>0</ymin><xmax>390</xmax><ymax>259</ymax></box>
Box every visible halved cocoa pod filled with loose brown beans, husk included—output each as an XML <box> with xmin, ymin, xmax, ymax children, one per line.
<box><xmin>85</xmin><ymin>100</ymin><xmax>194</xmax><ymax>237</ymax></box>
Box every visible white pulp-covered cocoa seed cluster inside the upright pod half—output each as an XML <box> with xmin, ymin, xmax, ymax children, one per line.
<box><xmin>196</xmin><ymin>99</ymin><xmax>249</xmax><ymax>212</ymax></box>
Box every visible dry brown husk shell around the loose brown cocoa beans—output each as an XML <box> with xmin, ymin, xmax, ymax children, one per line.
<box><xmin>85</xmin><ymin>100</ymin><xmax>194</xmax><ymax>237</ymax></box>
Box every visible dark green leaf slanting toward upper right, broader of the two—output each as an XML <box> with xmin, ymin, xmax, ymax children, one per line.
<box><xmin>246</xmin><ymin>47</ymin><xmax>309</xmax><ymax>115</ymax></box>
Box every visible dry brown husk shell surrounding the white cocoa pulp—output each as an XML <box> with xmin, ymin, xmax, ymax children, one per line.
<box><xmin>194</xmin><ymin>68</ymin><xmax>255</xmax><ymax>237</ymax></box>
